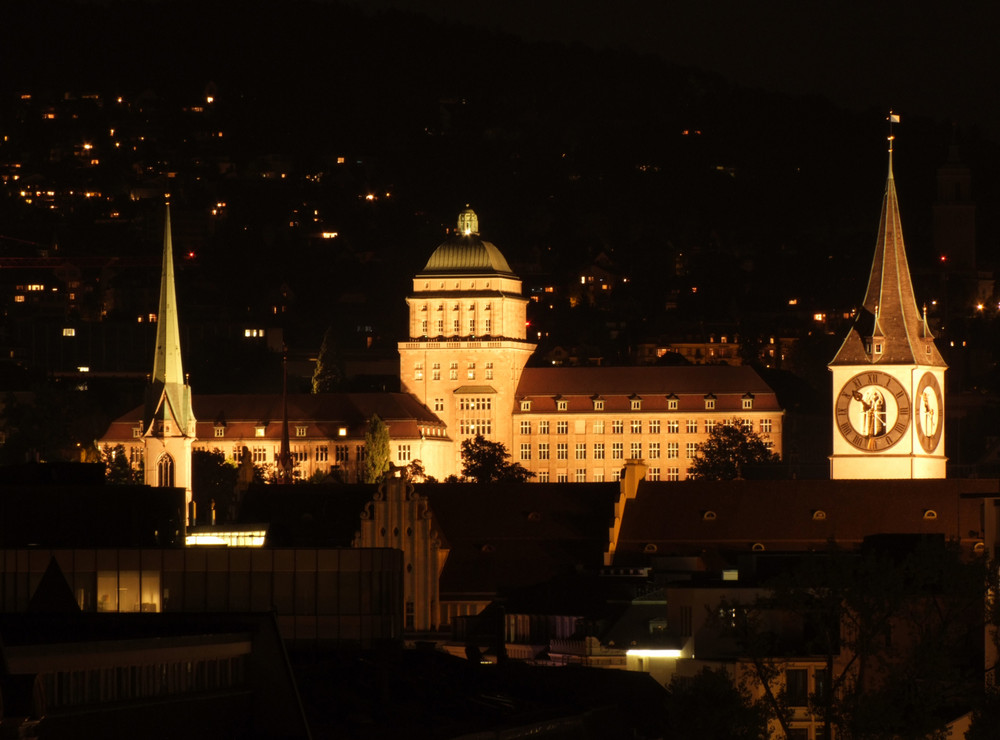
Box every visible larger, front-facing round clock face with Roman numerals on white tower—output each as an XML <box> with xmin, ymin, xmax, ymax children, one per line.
<box><xmin>837</xmin><ymin>370</ymin><xmax>911</xmax><ymax>452</ymax></box>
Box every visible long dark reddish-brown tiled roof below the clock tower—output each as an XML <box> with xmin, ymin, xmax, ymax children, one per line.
<box><xmin>615</xmin><ymin>480</ymin><xmax>997</xmax><ymax>565</ymax></box>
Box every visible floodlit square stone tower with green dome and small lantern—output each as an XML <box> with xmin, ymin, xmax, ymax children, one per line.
<box><xmin>399</xmin><ymin>208</ymin><xmax>535</xmax><ymax>475</ymax></box>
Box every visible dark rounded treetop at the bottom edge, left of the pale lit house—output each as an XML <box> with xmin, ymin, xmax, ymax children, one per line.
<box><xmin>667</xmin><ymin>668</ymin><xmax>768</xmax><ymax>740</ymax></box>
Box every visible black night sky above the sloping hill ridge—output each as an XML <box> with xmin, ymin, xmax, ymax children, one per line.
<box><xmin>348</xmin><ymin>0</ymin><xmax>1000</xmax><ymax>139</ymax></box>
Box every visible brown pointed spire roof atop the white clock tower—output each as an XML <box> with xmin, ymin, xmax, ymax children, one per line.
<box><xmin>830</xmin><ymin>148</ymin><xmax>945</xmax><ymax>367</ymax></box>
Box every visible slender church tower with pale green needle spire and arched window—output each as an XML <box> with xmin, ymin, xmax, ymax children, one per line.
<box><xmin>142</xmin><ymin>204</ymin><xmax>195</xmax><ymax>524</ymax></box>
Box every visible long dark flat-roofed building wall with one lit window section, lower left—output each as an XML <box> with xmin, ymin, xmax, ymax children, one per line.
<box><xmin>0</xmin><ymin>547</ymin><xmax>403</xmax><ymax>647</ymax></box>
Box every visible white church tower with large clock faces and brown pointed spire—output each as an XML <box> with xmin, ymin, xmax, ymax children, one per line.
<box><xmin>829</xmin><ymin>130</ymin><xmax>947</xmax><ymax>480</ymax></box>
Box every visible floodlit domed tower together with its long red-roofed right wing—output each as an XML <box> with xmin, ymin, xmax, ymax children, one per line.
<box><xmin>399</xmin><ymin>209</ymin><xmax>783</xmax><ymax>483</ymax></box>
